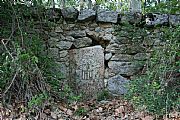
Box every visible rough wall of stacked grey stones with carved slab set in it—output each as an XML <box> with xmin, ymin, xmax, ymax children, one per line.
<box><xmin>48</xmin><ymin>8</ymin><xmax>180</xmax><ymax>99</ymax></box>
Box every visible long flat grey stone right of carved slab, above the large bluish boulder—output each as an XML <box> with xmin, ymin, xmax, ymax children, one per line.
<box><xmin>108</xmin><ymin>61</ymin><xmax>144</xmax><ymax>76</ymax></box>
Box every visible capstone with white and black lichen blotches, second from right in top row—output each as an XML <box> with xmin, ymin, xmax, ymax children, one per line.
<box><xmin>146</xmin><ymin>14</ymin><xmax>168</xmax><ymax>26</ymax></box>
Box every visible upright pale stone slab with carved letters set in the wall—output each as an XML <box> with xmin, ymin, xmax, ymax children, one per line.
<box><xmin>69</xmin><ymin>46</ymin><xmax>104</xmax><ymax>99</ymax></box>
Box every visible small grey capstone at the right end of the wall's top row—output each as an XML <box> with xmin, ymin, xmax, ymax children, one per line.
<box><xmin>169</xmin><ymin>15</ymin><xmax>180</xmax><ymax>26</ymax></box>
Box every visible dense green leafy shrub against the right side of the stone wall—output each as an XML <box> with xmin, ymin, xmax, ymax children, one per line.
<box><xmin>126</xmin><ymin>27</ymin><xmax>180</xmax><ymax>115</ymax></box>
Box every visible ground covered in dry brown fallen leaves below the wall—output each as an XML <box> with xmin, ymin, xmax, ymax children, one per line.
<box><xmin>0</xmin><ymin>98</ymin><xmax>180</xmax><ymax>120</ymax></box>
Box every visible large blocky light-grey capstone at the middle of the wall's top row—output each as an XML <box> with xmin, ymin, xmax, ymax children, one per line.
<box><xmin>97</xmin><ymin>10</ymin><xmax>118</xmax><ymax>23</ymax></box>
